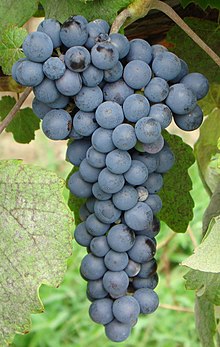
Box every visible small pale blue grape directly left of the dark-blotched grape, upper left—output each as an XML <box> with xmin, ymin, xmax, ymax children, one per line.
<box><xmin>43</xmin><ymin>57</ymin><xmax>66</xmax><ymax>80</ymax></box>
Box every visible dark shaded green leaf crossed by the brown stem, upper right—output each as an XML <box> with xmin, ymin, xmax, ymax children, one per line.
<box><xmin>167</xmin><ymin>18</ymin><xmax>220</xmax><ymax>83</ymax></box>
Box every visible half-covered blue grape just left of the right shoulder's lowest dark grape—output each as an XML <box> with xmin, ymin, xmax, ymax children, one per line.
<box><xmin>149</xmin><ymin>104</ymin><xmax>172</xmax><ymax>129</ymax></box>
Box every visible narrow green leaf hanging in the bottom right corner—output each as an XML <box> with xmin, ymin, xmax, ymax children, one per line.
<box><xmin>195</xmin><ymin>296</ymin><xmax>216</xmax><ymax>347</ymax></box>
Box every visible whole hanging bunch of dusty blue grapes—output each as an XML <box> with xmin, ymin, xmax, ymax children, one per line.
<box><xmin>12</xmin><ymin>15</ymin><xmax>209</xmax><ymax>342</ymax></box>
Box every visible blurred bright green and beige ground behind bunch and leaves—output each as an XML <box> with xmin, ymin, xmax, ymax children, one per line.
<box><xmin>0</xmin><ymin>125</ymin><xmax>209</xmax><ymax>347</ymax></box>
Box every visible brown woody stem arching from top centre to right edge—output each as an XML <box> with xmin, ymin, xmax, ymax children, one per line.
<box><xmin>111</xmin><ymin>0</ymin><xmax>220</xmax><ymax>66</ymax></box>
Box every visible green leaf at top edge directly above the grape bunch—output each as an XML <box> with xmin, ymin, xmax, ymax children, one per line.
<box><xmin>41</xmin><ymin>0</ymin><xmax>132</xmax><ymax>23</ymax></box>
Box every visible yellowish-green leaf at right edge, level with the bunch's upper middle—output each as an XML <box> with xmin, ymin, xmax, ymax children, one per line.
<box><xmin>195</xmin><ymin>85</ymin><xmax>220</xmax><ymax>192</ymax></box>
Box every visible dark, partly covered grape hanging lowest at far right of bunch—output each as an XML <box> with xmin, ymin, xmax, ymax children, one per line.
<box><xmin>174</xmin><ymin>105</ymin><xmax>203</xmax><ymax>131</ymax></box>
